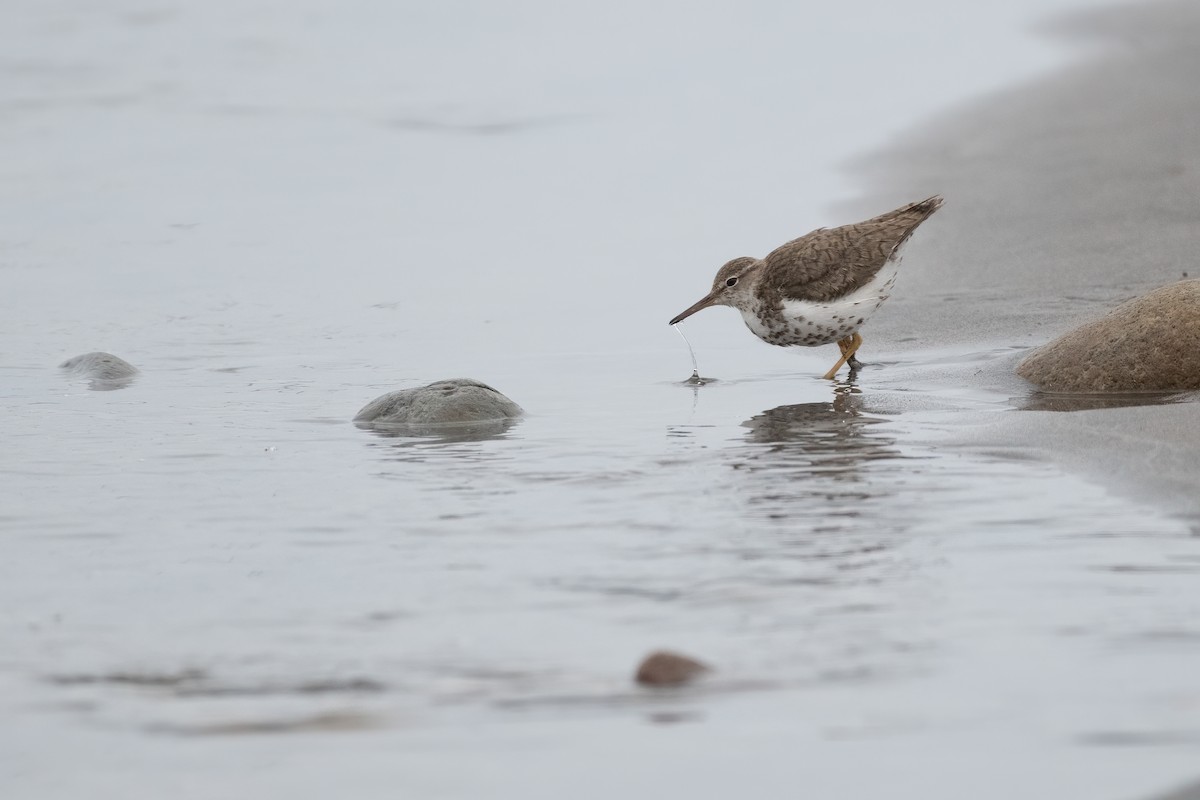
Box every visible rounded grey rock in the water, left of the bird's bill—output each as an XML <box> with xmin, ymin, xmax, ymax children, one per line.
<box><xmin>354</xmin><ymin>378</ymin><xmax>523</xmax><ymax>426</ymax></box>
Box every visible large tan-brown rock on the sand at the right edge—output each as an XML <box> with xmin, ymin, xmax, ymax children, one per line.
<box><xmin>1016</xmin><ymin>281</ymin><xmax>1200</xmax><ymax>392</ymax></box>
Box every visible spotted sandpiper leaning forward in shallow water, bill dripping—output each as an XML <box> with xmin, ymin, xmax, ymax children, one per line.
<box><xmin>671</xmin><ymin>194</ymin><xmax>942</xmax><ymax>380</ymax></box>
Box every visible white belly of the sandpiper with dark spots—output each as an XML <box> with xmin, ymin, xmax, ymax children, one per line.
<box><xmin>742</xmin><ymin>259</ymin><xmax>900</xmax><ymax>347</ymax></box>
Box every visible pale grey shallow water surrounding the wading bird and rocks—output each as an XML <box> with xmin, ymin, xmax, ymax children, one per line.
<box><xmin>0</xmin><ymin>4</ymin><xmax>1200</xmax><ymax>799</ymax></box>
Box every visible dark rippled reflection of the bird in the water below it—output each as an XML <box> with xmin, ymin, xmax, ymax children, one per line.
<box><xmin>731</xmin><ymin>383</ymin><xmax>901</xmax><ymax>531</ymax></box>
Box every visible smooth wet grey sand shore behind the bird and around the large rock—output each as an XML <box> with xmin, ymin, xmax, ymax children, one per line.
<box><xmin>847</xmin><ymin>0</ymin><xmax>1200</xmax><ymax>518</ymax></box>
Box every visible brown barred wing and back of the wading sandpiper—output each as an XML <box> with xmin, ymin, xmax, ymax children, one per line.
<box><xmin>757</xmin><ymin>196</ymin><xmax>942</xmax><ymax>307</ymax></box>
